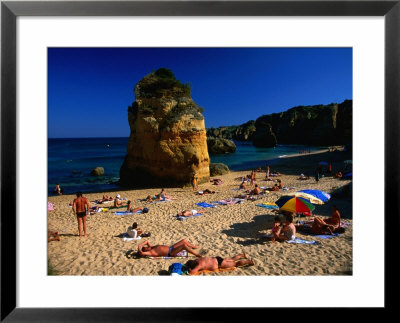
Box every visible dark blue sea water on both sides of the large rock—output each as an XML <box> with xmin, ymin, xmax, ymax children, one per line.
<box><xmin>48</xmin><ymin>138</ymin><xmax>321</xmax><ymax>194</ymax></box>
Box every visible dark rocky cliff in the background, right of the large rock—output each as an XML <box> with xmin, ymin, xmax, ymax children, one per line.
<box><xmin>207</xmin><ymin>100</ymin><xmax>353</xmax><ymax>147</ymax></box>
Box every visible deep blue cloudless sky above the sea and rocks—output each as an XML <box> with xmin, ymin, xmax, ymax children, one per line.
<box><xmin>48</xmin><ymin>48</ymin><xmax>353</xmax><ymax>138</ymax></box>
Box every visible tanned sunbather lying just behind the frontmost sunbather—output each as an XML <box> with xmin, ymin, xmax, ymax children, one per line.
<box><xmin>138</xmin><ymin>239</ymin><xmax>201</xmax><ymax>257</ymax></box>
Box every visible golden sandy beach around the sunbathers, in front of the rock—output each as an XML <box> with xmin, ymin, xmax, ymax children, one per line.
<box><xmin>48</xmin><ymin>151</ymin><xmax>353</xmax><ymax>276</ymax></box>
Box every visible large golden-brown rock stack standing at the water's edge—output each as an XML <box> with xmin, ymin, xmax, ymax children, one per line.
<box><xmin>120</xmin><ymin>68</ymin><xmax>210</xmax><ymax>186</ymax></box>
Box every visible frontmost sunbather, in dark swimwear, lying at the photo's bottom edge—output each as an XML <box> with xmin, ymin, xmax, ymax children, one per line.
<box><xmin>185</xmin><ymin>254</ymin><xmax>254</xmax><ymax>275</ymax></box>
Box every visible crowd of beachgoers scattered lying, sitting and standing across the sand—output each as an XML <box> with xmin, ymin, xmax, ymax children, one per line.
<box><xmin>48</xmin><ymin>165</ymin><xmax>350</xmax><ymax>274</ymax></box>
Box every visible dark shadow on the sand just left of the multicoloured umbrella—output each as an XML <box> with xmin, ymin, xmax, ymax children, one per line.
<box><xmin>222</xmin><ymin>214</ymin><xmax>274</xmax><ymax>238</ymax></box>
